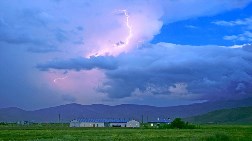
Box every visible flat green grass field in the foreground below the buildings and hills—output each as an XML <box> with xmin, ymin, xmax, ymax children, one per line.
<box><xmin>0</xmin><ymin>124</ymin><xmax>252</xmax><ymax>141</ymax></box>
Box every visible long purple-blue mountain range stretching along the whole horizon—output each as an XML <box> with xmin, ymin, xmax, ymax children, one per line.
<box><xmin>0</xmin><ymin>98</ymin><xmax>252</xmax><ymax>122</ymax></box>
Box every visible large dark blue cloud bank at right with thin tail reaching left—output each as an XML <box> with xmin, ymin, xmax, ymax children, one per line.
<box><xmin>38</xmin><ymin>43</ymin><xmax>252</xmax><ymax>100</ymax></box>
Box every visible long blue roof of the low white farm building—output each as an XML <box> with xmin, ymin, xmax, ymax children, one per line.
<box><xmin>73</xmin><ymin>118</ymin><xmax>130</xmax><ymax>123</ymax></box>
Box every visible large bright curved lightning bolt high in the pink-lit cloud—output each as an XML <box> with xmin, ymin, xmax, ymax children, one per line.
<box><xmin>115</xmin><ymin>10</ymin><xmax>133</xmax><ymax>47</ymax></box>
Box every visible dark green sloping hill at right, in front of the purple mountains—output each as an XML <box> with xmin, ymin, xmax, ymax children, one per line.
<box><xmin>185</xmin><ymin>106</ymin><xmax>252</xmax><ymax>124</ymax></box>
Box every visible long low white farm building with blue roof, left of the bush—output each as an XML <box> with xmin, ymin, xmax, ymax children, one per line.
<box><xmin>70</xmin><ymin>119</ymin><xmax>140</xmax><ymax>128</ymax></box>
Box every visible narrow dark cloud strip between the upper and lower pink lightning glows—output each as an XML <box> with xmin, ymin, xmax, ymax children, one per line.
<box><xmin>37</xmin><ymin>56</ymin><xmax>117</xmax><ymax>71</ymax></box>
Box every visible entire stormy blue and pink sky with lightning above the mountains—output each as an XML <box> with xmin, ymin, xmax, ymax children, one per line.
<box><xmin>0</xmin><ymin>0</ymin><xmax>252</xmax><ymax>110</ymax></box>
